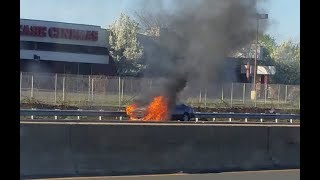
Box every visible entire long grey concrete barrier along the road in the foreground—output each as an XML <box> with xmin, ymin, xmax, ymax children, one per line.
<box><xmin>20</xmin><ymin>123</ymin><xmax>300</xmax><ymax>176</ymax></box>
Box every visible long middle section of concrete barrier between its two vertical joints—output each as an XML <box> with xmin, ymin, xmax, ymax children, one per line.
<box><xmin>71</xmin><ymin>125</ymin><xmax>270</xmax><ymax>175</ymax></box>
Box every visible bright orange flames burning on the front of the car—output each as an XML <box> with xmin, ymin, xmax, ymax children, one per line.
<box><xmin>126</xmin><ymin>96</ymin><xmax>168</xmax><ymax>121</ymax></box>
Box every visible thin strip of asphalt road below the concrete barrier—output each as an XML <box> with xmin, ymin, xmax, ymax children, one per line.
<box><xmin>30</xmin><ymin>169</ymin><xmax>300</xmax><ymax>180</ymax></box>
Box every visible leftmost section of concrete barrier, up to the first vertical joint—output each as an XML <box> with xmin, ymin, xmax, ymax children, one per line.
<box><xmin>20</xmin><ymin>124</ymin><xmax>76</xmax><ymax>176</ymax></box>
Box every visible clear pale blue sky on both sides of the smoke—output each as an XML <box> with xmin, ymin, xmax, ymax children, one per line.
<box><xmin>20</xmin><ymin>0</ymin><xmax>300</xmax><ymax>43</ymax></box>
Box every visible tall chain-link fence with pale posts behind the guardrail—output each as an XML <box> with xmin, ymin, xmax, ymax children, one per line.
<box><xmin>20</xmin><ymin>73</ymin><xmax>300</xmax><ymax>108</ymax></box>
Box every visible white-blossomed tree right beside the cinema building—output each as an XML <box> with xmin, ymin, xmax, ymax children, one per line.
<box><xmin>109</xmin><ymin>13</ymin><xmax>143</xmax><ymax>76</ymax></box>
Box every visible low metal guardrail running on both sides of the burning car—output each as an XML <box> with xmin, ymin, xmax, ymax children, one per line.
<box><xmin>20</xmin><ymin>109</ymin><xmax>300</xmax><ymax>121</ymax></box>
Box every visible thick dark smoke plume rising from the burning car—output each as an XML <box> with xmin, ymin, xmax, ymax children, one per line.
<box><xmin>131</xmin><ymin>0</ymin><xmax>263</xmax><ymax>115</ymax></box>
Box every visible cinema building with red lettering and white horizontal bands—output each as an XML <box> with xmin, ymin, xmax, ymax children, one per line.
<box><xmin>20</xmin><ymin>19</ymin><xmax>116</xmax><ymax>76</ymax></box>
